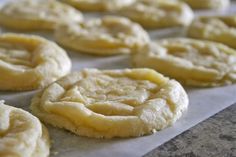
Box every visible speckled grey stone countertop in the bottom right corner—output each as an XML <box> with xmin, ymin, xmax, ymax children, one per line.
<box><xmin>144</xmin><ymin>103</ymin><xmax>236</xmax><ymax>157</ymax></box>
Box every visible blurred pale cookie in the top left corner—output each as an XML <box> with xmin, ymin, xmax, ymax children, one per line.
<box><xmin>0</xmin><ymin>0</ymin><xmax>83</xmax><ymax>31</ymax></box>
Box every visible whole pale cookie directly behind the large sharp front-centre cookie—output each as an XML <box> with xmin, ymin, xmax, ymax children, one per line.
<box><xmin>55</xmin><ymin>16</ymin><xmax>150</xmax><ymax>55</ymax></box>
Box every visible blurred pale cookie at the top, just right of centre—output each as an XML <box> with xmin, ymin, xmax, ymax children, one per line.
<box><xmin>117</xmin><ymin>0</ymin><xmax>194</xmax><ymax>29</ymax></box>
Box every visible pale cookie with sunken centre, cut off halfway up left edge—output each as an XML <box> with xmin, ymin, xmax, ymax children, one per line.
<box><xmin>0</xmin><ymin>33</ymin><xmax>71</xmax><ymax>90</ymax></box>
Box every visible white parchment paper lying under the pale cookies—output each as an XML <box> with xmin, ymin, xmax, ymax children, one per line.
<box><xmin>0</xmin><ymin>0</ymin><xmax>236</xmax><ymax>157</ymax></box>
